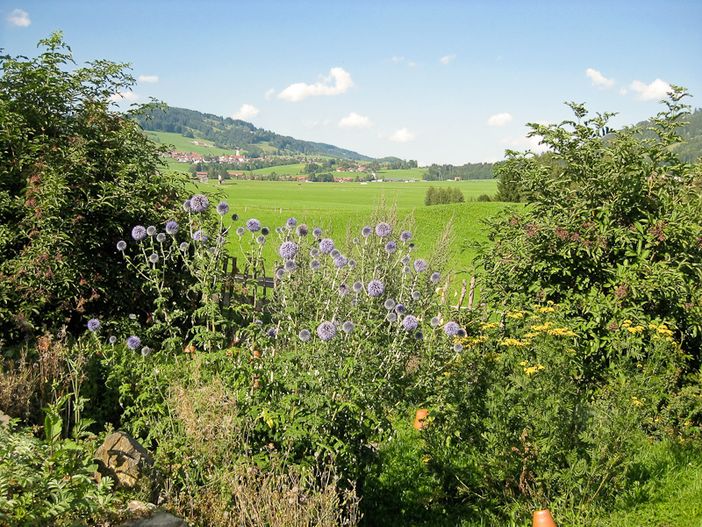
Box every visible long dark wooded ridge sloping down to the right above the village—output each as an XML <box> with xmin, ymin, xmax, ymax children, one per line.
<box><xmin>137</xmin><ymin>107</ymin><xmax>372</xmax><ymax>161</ymax></box>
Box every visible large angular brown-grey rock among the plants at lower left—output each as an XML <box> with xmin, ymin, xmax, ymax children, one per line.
<box><xmin>94</xmin><ymin>432</ymin><xmax>154</xmax><ymax>488</ymax></box>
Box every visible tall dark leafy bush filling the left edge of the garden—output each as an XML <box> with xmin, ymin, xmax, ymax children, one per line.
<box><xmin>0</xmin><ymin>34</ymin><xmax>190</xmax><ymax>344</ymax></box>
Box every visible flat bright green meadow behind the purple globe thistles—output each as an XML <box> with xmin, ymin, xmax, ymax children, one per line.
<box><xmin>192</xmin><ymin>180</ymin><xmax>506</xmax><ymax>286</ymax></box>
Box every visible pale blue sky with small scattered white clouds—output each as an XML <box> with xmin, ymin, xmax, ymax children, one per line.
<box><xmin>0</xmin><ymin>0</ymin><xmax>702</xmax><ymax>164</ymax></box>
